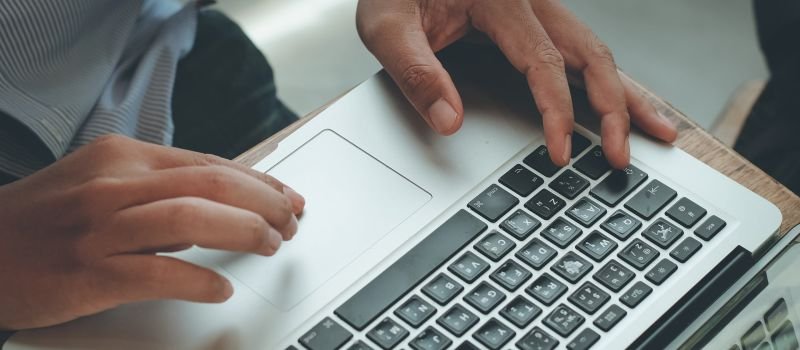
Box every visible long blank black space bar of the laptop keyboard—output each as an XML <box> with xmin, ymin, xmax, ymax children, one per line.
<box><xmin>335</xmin><ymin>210</ymin><xmax>486</xmax><ymax>330</ymax></box>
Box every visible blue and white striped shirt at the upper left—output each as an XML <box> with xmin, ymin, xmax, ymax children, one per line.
<box><xmin>0</xmin><ymin>0</ymin><xmax>197</xmax><ymax>177</ymax></box>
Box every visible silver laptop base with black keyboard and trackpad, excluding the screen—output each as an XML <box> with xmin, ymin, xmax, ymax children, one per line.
<box><xmin>5</xmin><ymin>45</ymin><xmax>781</xmax><ymax>350</ymax></box>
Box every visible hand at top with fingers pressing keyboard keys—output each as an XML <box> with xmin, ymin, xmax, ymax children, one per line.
<box><xmin>357</xmin><ymin>0</ymin><xmax>677</xmax><ymax>168</ymax></box>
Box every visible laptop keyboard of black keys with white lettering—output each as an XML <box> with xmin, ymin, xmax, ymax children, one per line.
<box><xmin>289</xmin><ymin>133</ymin><xmax>725</xmax><ymax>350</ymax></box>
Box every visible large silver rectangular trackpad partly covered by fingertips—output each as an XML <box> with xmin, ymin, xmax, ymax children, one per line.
<box><xmin>209</xmin><ymin>130</ymin><xmax>431</xmax><ymax>311</ymax></box>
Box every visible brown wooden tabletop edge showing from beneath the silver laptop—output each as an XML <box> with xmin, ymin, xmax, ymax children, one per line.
<box><xmin>236</xmin><ymin>73</ymin><xmax>800</xmax><ymax>234</ymax></box>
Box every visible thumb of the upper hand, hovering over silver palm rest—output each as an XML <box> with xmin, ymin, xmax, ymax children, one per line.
<box><xmin>361</xmin><ymin>15</ymin><xmax>464</xmax><ymax>135</ymax></box>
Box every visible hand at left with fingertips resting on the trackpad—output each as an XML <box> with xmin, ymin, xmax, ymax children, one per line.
<box><xmin>0</xmin><ymin>136</ymin><xmax>305</xmax><ymax>329</ymax></box>
